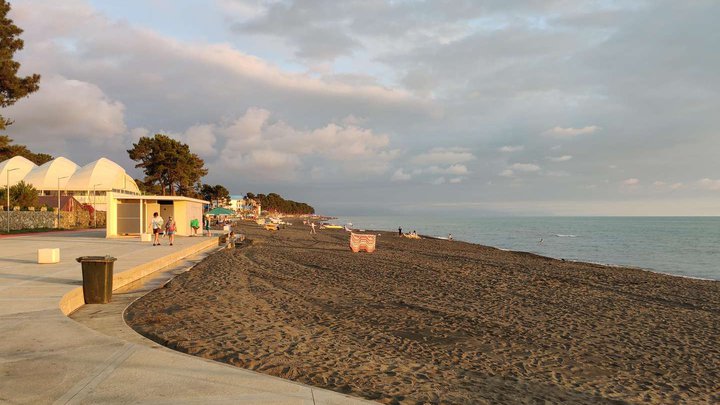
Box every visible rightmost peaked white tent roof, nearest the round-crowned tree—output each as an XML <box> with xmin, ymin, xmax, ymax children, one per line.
<box><xmin>65</xmin><ymin>158</ymin><xmax>140</xmax><ymax>193</ymax></box>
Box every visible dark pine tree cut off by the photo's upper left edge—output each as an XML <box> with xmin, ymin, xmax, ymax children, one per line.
<box><xmin>0</xmin><ymin>0</ymin><xmax>40</xmax><ymax>130</ymax></box>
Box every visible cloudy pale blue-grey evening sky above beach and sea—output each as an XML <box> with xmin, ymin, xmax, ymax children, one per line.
<box><xmin>3</xmin><ymin>0</ymin><xmax>720</xmax><ymax>215</ymax></box>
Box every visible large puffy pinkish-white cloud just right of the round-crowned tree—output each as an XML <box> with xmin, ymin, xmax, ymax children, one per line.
<box><xmin>214</xmin><ymin>108</ymin><xmax>396</xmax><ymax>180</ymax></box>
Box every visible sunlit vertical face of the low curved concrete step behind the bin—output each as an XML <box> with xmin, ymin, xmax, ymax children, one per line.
<box><xmin>58</xmin><ymin>238</ymin><xmax>218</xmax><ymax>316</ymax></box>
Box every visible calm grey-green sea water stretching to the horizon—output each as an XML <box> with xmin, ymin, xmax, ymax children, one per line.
<box><xmin>334</xmin><ymin>216</ymin><xmax>720</xmax><ymax>280</ymax></box>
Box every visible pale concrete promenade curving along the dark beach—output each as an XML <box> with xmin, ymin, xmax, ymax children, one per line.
<box><xmin>0</xmin><ymin>231</ymin><xmax>368</xmax><ymax>405</ymax></box>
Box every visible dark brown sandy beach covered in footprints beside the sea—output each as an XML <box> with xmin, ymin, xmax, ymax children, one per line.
<box><xmin>125</xmin><ymin>223</ymin><xmax>720</xmax><ymax>404</ymax></box>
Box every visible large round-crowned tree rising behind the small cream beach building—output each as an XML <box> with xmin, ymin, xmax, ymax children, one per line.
<box><xmin>127</xmin><ymin>134</ymin><xmax>208</xmax><ymax>195</ymax></box>
